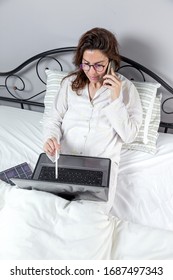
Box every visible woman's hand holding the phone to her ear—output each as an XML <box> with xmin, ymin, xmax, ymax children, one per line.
<box><xmin>103</xmin><ymin>68</ymin><xmax>122</xmax><ymax>100</ymax></box>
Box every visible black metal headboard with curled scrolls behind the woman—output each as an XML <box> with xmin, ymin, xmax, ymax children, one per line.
<box><xmin>0</xmin><ymin>47</ymin><xmax>173</xmax><ymax>132</ymax></box>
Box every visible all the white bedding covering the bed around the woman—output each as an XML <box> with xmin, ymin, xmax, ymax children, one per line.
<box><xmin>0</xmin><ymin>106</ymin><xmax>173</xmax><ymax>260</ymax></box>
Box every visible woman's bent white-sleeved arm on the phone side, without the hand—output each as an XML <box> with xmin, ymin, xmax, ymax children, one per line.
<box><xmin>104</xmin><ymin>81</ymin><xmax>142</xmax><ymax>143</ymax></box>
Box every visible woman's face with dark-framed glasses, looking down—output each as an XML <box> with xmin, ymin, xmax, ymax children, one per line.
<box><xmin>81</xmin><ymin>50</ymin><xmax>109</xmax><ymax>83</ymax></box>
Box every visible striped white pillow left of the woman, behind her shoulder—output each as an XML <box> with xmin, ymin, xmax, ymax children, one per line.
<box><xmin>43</xmin><ymin>69</ymin><xmax>68</xmax><ymax>119</ymax></box>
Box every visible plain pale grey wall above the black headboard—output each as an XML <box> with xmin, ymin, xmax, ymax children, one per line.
<box><xmin>0</xmin><ymin>0</ymin><xmax>173</xmax><ymax>121</ymax></box>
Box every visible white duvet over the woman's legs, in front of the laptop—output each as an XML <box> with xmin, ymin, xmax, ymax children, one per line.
<box><xmin>0</xmin><ymin>179</ymin><xmax>173</xmax><ymax>260</ymax></box>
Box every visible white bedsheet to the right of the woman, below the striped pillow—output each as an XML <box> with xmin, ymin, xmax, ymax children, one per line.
<box><xmin>113</xmin><ymin>133</ymin><xmax>173</xmax><ymax>231</ymax></box>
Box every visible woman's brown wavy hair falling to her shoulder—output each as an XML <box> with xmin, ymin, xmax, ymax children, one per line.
<box><xmin>68</xmin><ymin>27</ymin><xmax>120</xmax><ymax>94</ymax></box>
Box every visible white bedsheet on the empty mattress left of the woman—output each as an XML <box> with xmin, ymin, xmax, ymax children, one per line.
<box><xmin>0</xmin><ymin>106</ymin><xmax>43</xmax><ymax>171</ymax></box>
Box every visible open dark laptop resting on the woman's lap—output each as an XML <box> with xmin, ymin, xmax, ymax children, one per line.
<box><xmin>11</xmin><ymin>153</ymin><xmax>111</xmax><ymax>201</ymax></box>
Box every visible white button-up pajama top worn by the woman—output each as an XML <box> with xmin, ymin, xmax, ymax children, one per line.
<box><xmin>44</xmin><ymin>74</ymin><xmax>142</xmax><ymax>164</ymax></box>
